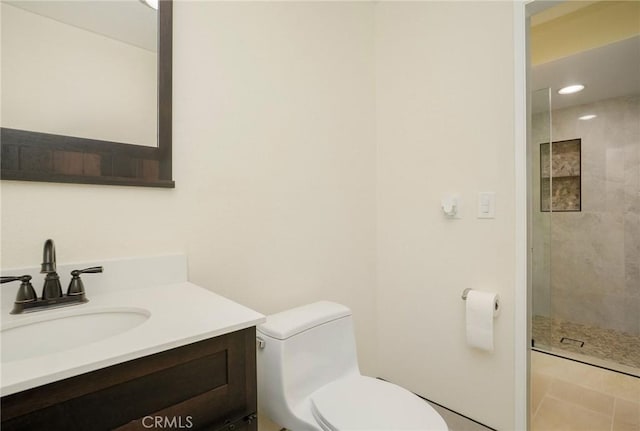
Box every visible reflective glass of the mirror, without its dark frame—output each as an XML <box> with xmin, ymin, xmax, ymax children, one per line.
<box><xmin>2</xmin><ymin>0</ymin><xmax>158</xmax><ymax>147</ymax></box>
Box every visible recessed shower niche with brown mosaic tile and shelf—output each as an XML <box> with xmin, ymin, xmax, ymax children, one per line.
<box><xmin>540</xmin><ymin>139</ymin><xmax>582</xmax><ymax>212</ymax></box>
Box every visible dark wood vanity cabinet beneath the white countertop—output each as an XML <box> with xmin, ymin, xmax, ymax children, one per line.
<box><xmin>2</xmin><ymin>327</ymin><xmax>258</xmax><ymax>431</ymax></box>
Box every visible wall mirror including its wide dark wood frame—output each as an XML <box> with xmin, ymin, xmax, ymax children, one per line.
<box><xmin>2</xmin><ymin>0</ymin><xmax>175</xmax><ymax>187</ymax></box>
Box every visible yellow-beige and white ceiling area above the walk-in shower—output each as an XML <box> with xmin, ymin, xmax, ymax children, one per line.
<box><xmin>530</xmin><ymin>1</ymin><xmax>640</xmax><ymax>109</ymax></box>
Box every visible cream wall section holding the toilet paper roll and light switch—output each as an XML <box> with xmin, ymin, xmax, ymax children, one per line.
<box><xmin>376</xmin><ymin>2</ymin><xmax>515</xmax><ymax>430</ymax></box>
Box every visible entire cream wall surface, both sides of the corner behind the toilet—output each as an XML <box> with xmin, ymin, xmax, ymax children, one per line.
<box><xmin>2</xmin><ymin>1</ymin><xmax>515</xmax><ymax>429</ymax></box>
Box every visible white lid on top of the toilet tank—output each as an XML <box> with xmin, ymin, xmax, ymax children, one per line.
<box><xmin>257</xmin><ymin>301</ymin><xmax>351</xmax><ymax>340</ymax></box>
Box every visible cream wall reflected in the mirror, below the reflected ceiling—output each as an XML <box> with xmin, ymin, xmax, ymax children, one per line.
<box><xmin>0</xmin><ymin>2</ymin><xmax>157</xmax><ymax>147</ymax></box>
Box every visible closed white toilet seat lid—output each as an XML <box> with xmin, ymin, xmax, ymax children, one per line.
<box><xmin>311</xmin><ymin>375</ymin><xmax>448</xmax><ymax>431</ymax></box>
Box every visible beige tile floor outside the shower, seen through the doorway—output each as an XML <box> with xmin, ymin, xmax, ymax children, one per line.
<box><xmin>531</xmin><ymin>351</ymin><xmax>640</xmax><ymax>431</ymax></box>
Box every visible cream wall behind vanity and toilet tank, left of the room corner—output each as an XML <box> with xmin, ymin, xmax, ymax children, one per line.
<box><xmin>2</xmin><ymin>2</ymin><xmax>375</xmax><ymax>371</ymax></box>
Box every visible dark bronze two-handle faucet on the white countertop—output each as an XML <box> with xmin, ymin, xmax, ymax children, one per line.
<box><xmin>0</xmin><ymin>239</ymin><xmax>102</xmax><ymax>314</ymax></box>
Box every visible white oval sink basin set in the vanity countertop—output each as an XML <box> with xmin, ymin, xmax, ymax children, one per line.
<box><xmin>1</xmin><ymin>307</ymin><xmax>151</xmax><ymax>363</ymax></box>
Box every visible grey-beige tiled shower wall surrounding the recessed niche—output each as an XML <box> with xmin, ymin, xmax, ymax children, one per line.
<box><xmin>532</xmin><ymin>96</ymin><xmax>640</xmax><ymax>335</ymax></box>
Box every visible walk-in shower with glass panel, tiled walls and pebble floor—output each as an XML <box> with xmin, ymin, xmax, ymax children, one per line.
<box><xmin>528</xmin><ymin>36</ymin><xmax>640</xmax><ymax>376</ymax></box>
